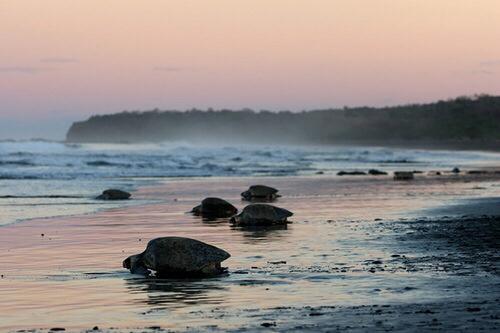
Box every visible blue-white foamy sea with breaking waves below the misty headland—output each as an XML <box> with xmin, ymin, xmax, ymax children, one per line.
<box><xmin>0</xmin><ymin>141</ymin><xmax>500</xmax><ymax>226</ymax></box>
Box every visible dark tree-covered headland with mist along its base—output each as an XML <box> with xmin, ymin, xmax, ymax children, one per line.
<box><xmin>66</xmin><ymin>95</ymin><xmax>500</xmax><ymax>150</ymax></box>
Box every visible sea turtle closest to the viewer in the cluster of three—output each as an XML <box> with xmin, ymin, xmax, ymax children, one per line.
<box><xmin>231</xmin><ymin>204</ymin><xmax>293</xmax><ymax>226</ymax></box>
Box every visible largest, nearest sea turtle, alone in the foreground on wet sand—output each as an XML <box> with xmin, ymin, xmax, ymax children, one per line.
<box><xmin>123</xmin><ymin>237</ymin><xmax>231</xmax><ymax>277</ymax></box>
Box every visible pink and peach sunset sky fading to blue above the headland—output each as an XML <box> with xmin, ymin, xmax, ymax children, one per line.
<box><xmin>0</xmin><ymin>0</ymin><xmax>500</xmax><ymax>139</ymax></box>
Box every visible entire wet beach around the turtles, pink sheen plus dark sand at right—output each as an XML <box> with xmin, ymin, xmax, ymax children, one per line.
<box><xmin>0</xmin><ymin>173</ymin><xmax>500</xmax><ymax>332</ymax></box>
